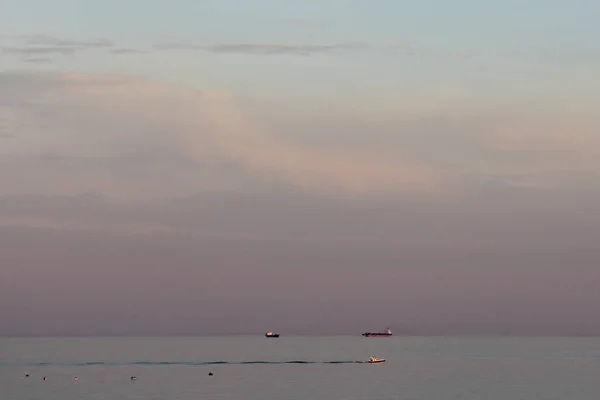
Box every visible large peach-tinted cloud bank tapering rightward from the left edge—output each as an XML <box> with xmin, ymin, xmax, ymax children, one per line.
<box><xmin>0</xmin><ymin>73</ymin><xmax>437</xmax><ymax>199</ymax></box>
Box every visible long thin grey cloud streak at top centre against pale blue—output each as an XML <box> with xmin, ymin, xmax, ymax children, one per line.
<box><xmin>155</xmin><ymin>43</ymin><xmax>365</xmax><ymax>55</ymax></box>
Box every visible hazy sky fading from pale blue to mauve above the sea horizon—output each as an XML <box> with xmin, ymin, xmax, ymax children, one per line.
<box><xmin>0</xmin><ymin>0</ymin><xmax>600</xmax><ymax>335</ymax></box>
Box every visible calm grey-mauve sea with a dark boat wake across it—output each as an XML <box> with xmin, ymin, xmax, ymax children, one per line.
<box><xmin>0</xmin><ymin>335</ymin><xmax>600</xmax><ymax>400</ymax></box>
